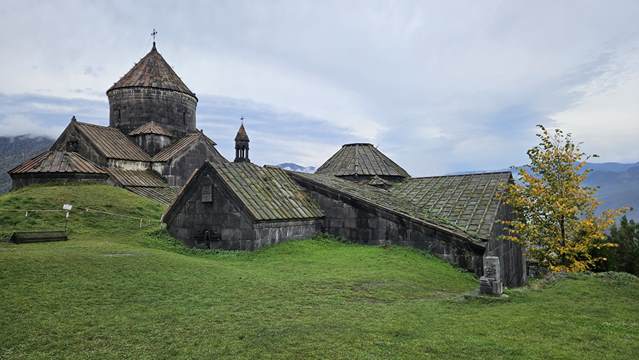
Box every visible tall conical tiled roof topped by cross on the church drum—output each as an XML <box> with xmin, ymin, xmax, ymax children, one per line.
<box><xmin>107</xmin><ymin>42</ymin><xmax>195</xmax><ymax>97</ymax></box>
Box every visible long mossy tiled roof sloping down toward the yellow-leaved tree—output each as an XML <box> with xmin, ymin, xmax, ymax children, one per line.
<box><xmin>290</xmin><ymin>172</ymin><xmax>510</xmax><ymax>241</ymax></box>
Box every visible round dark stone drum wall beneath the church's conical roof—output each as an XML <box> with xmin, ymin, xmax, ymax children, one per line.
<box><xmin>107</xmin><ymin>88</ymin><xmax>197</xmax><ymax>137</ymax></box>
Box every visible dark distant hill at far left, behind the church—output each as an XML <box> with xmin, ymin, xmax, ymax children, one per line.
<box><xmin>0</xmin><ymin>135</ymin><xmax>54</xmax><ymax>194</ymax></box>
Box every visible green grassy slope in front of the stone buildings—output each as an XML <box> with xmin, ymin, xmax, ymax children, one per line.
<box><xmin>0</xmin><ymin>185</ymin><xmax>639</xmax><ymax>359</ymax></box>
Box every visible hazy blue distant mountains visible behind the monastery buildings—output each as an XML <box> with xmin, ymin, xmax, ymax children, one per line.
<box><xmin>0</xmin><ymin>135</ymin><xmax>639</xmax><ymax>220</ymax></box>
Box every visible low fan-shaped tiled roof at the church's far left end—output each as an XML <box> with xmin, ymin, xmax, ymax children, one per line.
<box><xmin>9</xmin><ymin>151</ymin><xmax>107</xmax><ymax>174</ymax></box>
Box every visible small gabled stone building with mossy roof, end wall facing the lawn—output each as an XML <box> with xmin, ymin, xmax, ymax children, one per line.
<box><xmin>163</xmin><ymin>162</ymin><xmax>323</xmax><ymax>250</ymax></box>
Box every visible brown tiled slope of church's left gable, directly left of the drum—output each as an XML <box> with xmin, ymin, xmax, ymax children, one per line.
<box><xmin>72</xmin><ymin>121</ymin><xmax>151</xmax><ymax>161</ymax></box>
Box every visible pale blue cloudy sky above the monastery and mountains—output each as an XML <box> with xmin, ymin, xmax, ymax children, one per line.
<box><xmin>0</xmin><ymin>0</ymin><xmax>639</xmax><ymax>176</ymax></box>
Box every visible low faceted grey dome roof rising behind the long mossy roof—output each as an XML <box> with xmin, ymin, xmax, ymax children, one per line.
<box><xmin>316</xmin><ymin>143</ymin><xmax>410</xmax><ymax>177</ymax></box>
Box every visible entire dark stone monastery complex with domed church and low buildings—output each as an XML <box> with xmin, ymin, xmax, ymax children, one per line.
<box><xmin>10</xmin><ymin>42</ymin><xmax>526</xmax><ymax>286</ymax></box>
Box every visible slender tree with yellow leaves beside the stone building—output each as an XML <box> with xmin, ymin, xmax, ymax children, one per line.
<box><xmin>502</xmin><ymin>125</ymin><xmax>625</xmax><ymax>272</ymax></box>
